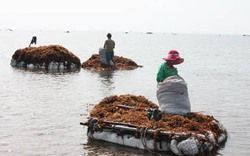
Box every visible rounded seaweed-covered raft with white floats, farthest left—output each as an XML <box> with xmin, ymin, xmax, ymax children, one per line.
<box><xmin>11</xmin><ymin>45</ymin><xmax>81</xmax><ymax>70</ymax></box>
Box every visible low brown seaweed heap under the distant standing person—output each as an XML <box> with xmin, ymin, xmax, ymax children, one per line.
<box><xmin>82</xmin><ymin>54</ymin><xmax>142</xmax><ymax>71</ymax></box>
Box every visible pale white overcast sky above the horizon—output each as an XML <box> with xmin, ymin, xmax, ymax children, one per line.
<box><xmin>0</xmin><ymin>0</ymin><xmax>250</xmax><ymax>34</ymax></box>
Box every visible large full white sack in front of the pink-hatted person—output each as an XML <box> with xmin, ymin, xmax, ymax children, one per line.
<box><xmin>157</xmin><ymin>76</ymin><xmax>190</xmax><ymax>114</ymax></box>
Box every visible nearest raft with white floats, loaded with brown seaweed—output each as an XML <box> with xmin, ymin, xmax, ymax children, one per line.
<box><xmin>81</xmin><ymin>94</ymin><xmax>227</xmax><ymax>155</ymax></box>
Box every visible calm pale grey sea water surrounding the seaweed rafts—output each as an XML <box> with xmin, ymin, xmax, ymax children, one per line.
<box><xmin>0</xmin><ymin>30</ymin><xmax>250</xmax><ymax>156</ymax></box>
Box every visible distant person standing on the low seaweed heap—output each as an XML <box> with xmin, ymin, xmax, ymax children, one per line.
<box><xmin>103</xmin><ymin>33</ymin><xmax>115</xmax><ymax>66</ymax></box>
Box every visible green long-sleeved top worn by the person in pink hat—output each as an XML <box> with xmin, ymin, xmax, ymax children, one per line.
<box><xmin>156</xmin><ymin>62</ymin><xmax>178</xmax><ymax>82</ymax></box>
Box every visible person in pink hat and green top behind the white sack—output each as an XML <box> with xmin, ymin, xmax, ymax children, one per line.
<box><xmin>156</xmin><ymin>50</ymin><xmax>184</xmax><ymax>83</ymax></box>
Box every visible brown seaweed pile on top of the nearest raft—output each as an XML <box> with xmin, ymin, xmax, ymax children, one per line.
<box><xmin>90</xmin><ymin>94</ymin><xmax>223</xmax><ymax>136</ymax></box>
